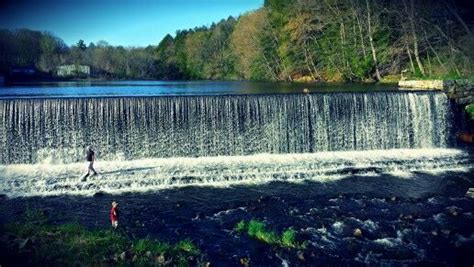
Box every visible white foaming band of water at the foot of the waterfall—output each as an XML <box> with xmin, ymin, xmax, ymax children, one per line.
<box><xmin>0</xmin><ymin>149</ymin><xmax>471</xmax><ymax>197</ymax></box>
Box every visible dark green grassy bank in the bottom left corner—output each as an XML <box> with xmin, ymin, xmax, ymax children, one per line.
<box><xmin>0</xmin><ymin>211</ymin><xmax>201</xmax><ymax>266</ymax></box>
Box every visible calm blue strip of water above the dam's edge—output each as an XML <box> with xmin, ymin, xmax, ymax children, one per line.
<box><xmin>0</xmin><ymin>81</ymin><xmax>397</xmax><ymax>98</ymax></box>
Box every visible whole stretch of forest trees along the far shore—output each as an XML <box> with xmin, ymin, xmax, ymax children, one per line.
<box><xmin>0</xmin><ymin>0</ymin><xmax>474</xmax><ymax>82</ymax></box>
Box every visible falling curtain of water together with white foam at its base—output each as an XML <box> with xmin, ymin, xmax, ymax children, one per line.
<box><xmin>0</xmin><ymin>92</ymin><xmax>468</xmax><ymax>196</ymax></box>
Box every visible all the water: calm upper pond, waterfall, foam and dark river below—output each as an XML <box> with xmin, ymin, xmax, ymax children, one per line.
<box><xmin>0</xmin><ymin>81</ymin><xmax>474</xmax><ymax>266</ymax></box>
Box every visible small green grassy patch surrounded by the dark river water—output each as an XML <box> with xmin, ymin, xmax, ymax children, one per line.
<box><xmin>234</xmin><ymin>219</ymin><xmax>307</xmax><ymax>249</ymax></box>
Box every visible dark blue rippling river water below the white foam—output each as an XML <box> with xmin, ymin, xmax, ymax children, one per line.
<box><xmin>0</xmin><ymin>169</ymin><xmax>474</xmax><ymax>266</ymax></box>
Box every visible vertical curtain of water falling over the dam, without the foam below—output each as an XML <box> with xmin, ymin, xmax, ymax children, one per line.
<box><xmin>0</xmin><ymin>92</ymin><xmax>450</xmax><ymax>164</ymax></box>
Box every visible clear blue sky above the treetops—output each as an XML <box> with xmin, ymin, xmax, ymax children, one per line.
<box><xmin>0</xmin><ymin>0</ymin><xmax>263</xmax><ymax>47</ymax></box>
